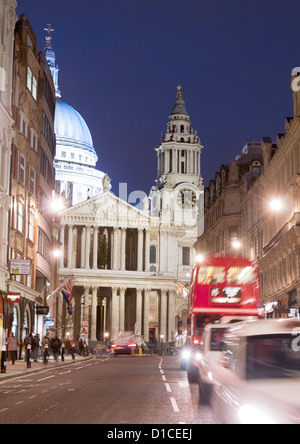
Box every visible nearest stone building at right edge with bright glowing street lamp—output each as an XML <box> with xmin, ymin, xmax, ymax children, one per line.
<box><xmin>242</xmin><ymin>72</ymin><xmax>300</xmax><ymax>317</ymax></box>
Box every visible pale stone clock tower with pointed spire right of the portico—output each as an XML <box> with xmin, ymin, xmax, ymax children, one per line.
<box><xmin>150</xmin><ymin>85</ymin><xmax>203</xmax><ymax>234</ymax></box>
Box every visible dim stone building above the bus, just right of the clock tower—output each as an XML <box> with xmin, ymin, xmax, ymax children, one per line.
<box><xmin>195</xmin><ymin>141</ymin><xmax>263</xmax><ymax>256</ymax></box>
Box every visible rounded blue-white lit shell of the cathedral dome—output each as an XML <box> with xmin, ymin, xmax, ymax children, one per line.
<box><xmin>54</xmin><ymin>100</ymin><xmax>96</xmax><ymax>155</ymax></box>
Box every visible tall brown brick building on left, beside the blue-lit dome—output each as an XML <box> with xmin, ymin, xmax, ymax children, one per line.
<box><xmin>5</xmin><ymin>14</ymin><xmax>59</xmax><ymax>341</ymax></box>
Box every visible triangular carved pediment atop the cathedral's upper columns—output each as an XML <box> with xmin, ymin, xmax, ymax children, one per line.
<box><xmin>61</xmin><ymin>192</ymin><xmax>152</xmax><ymax>228</ymax></box>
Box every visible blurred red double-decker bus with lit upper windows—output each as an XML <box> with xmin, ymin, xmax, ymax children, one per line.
<box><xmin>188</xmin><ymin>256</ymin><xmax>261</xmax><ymax>378</ymax></box>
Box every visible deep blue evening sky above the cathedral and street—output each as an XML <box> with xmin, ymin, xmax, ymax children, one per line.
<box><xmin>17</xmin><ymin>0</ymin><xmax>300</xmax><ymax>198</ymax></box>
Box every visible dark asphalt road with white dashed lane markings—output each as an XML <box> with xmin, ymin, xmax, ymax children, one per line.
<box><xmin>0</xmin><ymin>356</ymin><xmax>214</xmax><ymax>425</ymax></box>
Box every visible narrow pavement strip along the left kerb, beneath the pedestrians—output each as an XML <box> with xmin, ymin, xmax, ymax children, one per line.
<box><xmin>0</xmin><ymin>355</ymin><xmax>94</xmax><ymax>383</ymax></box>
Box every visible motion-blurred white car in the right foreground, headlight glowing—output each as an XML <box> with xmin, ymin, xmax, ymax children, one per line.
<box><xmin>211</xmin><ymin>319</ymin><xmax>300</xmax><ymax>424</ymax></box>
